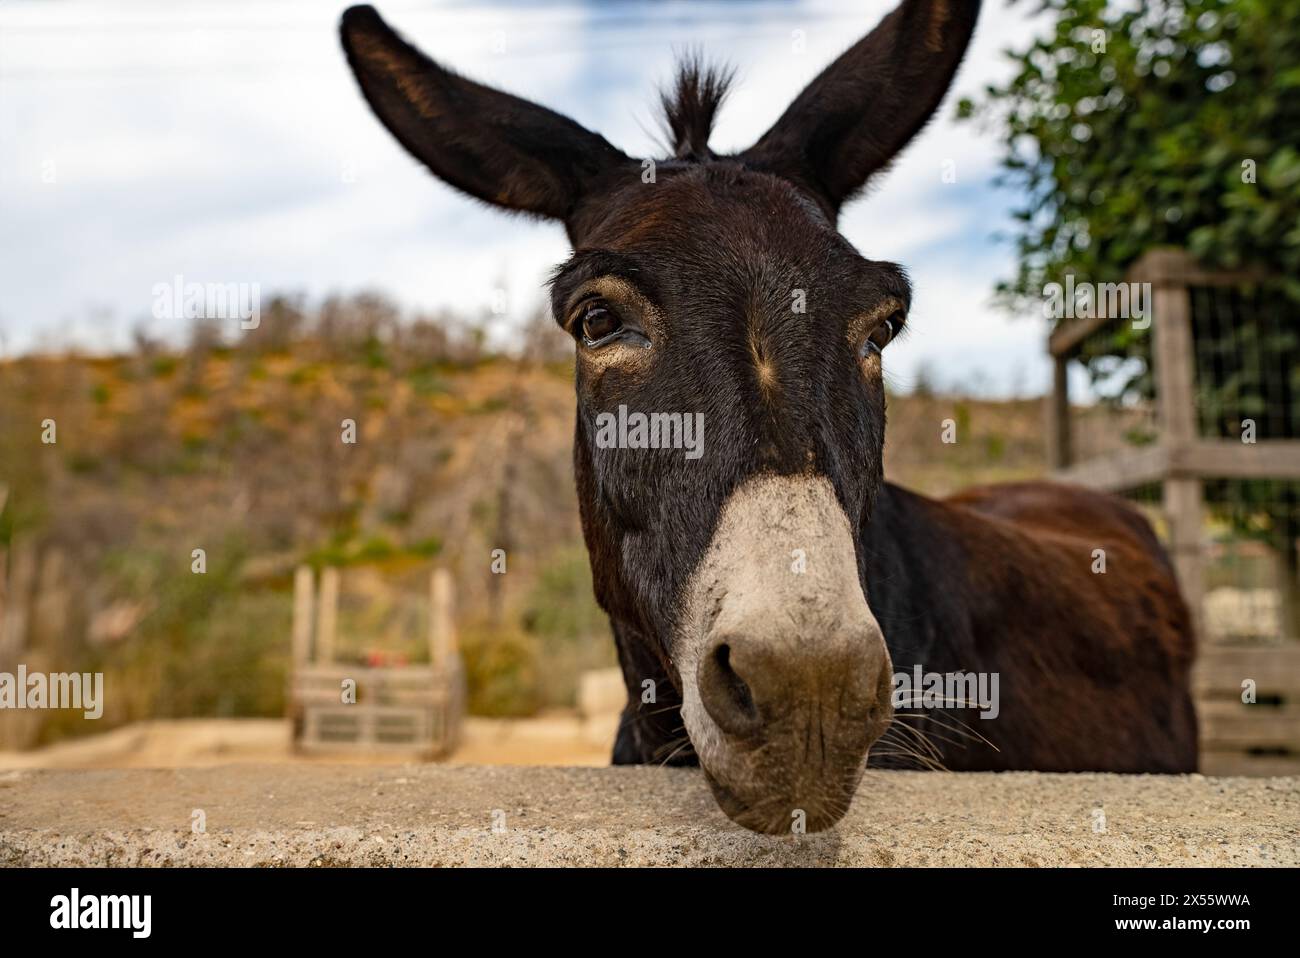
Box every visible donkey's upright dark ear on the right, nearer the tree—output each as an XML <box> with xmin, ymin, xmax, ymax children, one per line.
<box><xmin>741</xmin><ymin>0</ymin><xmax>980</xmax><ymax>214</ymax></box>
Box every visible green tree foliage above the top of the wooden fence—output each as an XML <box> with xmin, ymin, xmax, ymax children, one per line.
<box><xmin>958</xmin><ymin>0</ymin><xmax>1300</xmax><ymax>324</ymax></box>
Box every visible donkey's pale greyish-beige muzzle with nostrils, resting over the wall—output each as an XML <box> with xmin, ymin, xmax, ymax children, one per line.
<box><xmin>679</xmin><ymin>477</ymin><xmax>892</xmax><ymax>833</ymax></box>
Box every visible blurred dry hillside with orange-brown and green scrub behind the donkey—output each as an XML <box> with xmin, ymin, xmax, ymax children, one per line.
<box><xmin>0</xmin><ymin>298</ymin><xmax>1123</xmax><ymax>747</ymax></box>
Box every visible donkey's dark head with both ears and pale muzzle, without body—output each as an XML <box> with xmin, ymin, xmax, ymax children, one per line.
<box><xmin>342</xmin><ymin>0</ymin><xmax>979</xmax><ymax>832</ymax></box>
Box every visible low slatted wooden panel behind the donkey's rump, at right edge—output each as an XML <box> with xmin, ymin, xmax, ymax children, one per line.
<box><xmin>1192</xmin><ymin>643</ymin><xmax>1300</xmax><ymax>775</ymax></box>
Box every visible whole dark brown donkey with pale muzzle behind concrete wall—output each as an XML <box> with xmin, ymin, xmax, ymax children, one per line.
<box><xmin>342</xmin><ymin>0</ymin><xmax>1196</xmax><ymax>833</ymax></box>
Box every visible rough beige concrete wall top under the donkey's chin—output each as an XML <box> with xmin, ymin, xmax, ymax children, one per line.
<box><xmin>0</xmin><ymin>766</ymin><xmax>1300</xmax><ymax>866</ymax></box>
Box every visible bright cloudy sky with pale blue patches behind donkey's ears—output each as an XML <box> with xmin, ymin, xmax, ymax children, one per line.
<box><xmin>0</xmin><ymin>0</ymin><xmax>1087</xmax><ymax>395</ymax></box>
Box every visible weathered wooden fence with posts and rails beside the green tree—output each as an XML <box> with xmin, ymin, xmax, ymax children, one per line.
<box><xmin>1048</xmin><ymin>250</ymin><xmax>1300</xmax><ymax>775</ymax></box>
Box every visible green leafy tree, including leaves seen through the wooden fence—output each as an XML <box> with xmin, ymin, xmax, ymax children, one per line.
<box><xmin>958</xmin><ymin>0</ymin><xmax>1300</xmax><ymax>631</ymax></box>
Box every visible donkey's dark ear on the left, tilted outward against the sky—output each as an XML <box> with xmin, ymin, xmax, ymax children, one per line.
<box><xmin>339</xmin><ymin>6</ymin><xmax>638</xmax><ymax>220</ymax></box>
